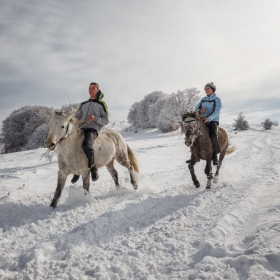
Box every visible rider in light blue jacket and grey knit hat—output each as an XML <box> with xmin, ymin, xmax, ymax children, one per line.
<box><xmin>188</xmin><ymin>83</ymin><xmax>223</xmax><ymax>165</ymax></box>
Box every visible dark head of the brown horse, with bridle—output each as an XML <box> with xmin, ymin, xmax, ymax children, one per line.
<box><xmin>182</xmin><ymin>112</ymin><xmax>201</xmax><ymax>147</ymax></box>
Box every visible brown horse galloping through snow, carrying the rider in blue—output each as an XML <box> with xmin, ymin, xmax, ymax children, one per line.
<box><xmin>182</xmin><ymin>112</ymin><xmax>235</xmax><ymax>189</ymax></box>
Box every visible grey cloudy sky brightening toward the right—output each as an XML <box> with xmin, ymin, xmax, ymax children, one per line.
<box><xmin>0</xmin><ymin>0</ymin><xmax>280</xmax><ymax>125</ymax></box>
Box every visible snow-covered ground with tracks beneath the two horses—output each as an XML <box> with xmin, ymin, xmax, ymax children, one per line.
<box><xmin>0</xmin><ymin>124</ymin><xmax>280</xmax><ymax>280</ymax></box>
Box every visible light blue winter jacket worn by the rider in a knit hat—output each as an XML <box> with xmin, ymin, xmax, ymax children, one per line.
<box><xmin>195</xmin><ymin>93</ymin><xmax>223</xmax><ymax>122</ymax></box>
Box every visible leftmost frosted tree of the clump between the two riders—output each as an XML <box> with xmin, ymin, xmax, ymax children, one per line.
<box><xmin>137</xmin><ymin>91</ymin><xmax>166</xmax><ymax>128</ymax></box>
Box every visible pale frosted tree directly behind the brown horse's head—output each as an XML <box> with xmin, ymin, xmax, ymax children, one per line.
<box><xmin>157</xmin><ymin>88</ymin><xmax>200</xmax><ymax>132</ymax></box>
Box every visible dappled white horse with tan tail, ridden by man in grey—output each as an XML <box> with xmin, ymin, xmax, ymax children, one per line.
<box><xmin>45</xmin><ymin>110</ymin><xmax>139</xmax><ymax>208</ymax></box>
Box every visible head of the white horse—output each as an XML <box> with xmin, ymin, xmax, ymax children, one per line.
<box><xmin>45</xmin><ymin>108</ymin><xmax>73</xmax><ymax>150</ymax></box>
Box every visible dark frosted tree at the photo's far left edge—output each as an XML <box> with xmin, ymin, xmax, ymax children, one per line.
<box><xmin>2</xmin><ymin>106</ymin><xmax>52</xmax><ymax>153</ymax></box>
